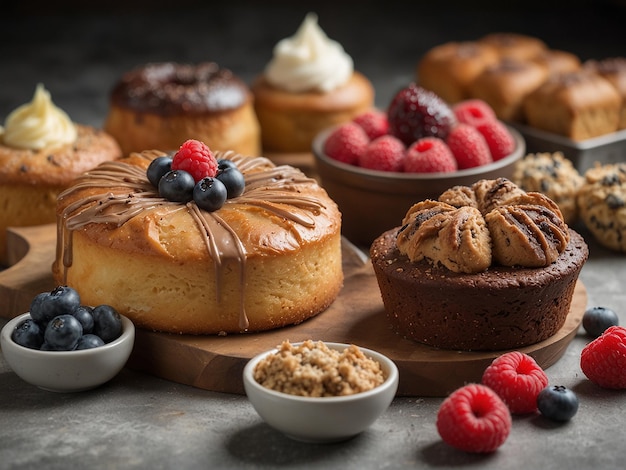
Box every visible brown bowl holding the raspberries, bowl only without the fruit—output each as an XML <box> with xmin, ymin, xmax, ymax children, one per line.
<box><xmin>312</xmin><ymin>127</ymin><xmax>526</xmax><ymax>247</ymax></box>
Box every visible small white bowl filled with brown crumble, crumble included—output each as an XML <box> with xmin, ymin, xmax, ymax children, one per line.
<box><xmin>243</xmin><ymin>340</ymin><xmax>399</xmax><ymax>443</ymax></box>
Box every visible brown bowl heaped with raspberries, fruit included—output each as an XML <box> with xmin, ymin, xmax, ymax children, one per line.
<box><xmin>312</xmin><ymin>83</ymin><xmax>526</xmax><ymax>246</ymax></box>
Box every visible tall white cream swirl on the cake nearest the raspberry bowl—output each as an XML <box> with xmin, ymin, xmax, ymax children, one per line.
<box><xmin>265</xmin><ymin>13</ymin><xmax>354</xmax><ymax>93</ymax></box>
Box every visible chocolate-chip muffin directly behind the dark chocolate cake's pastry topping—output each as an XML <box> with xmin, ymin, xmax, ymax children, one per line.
<box><xmin>513</xmin><ymin>152</ymin><xmax>584</xmax><ymax>225</ymax></box>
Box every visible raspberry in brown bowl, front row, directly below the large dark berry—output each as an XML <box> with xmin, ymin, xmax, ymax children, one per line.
<box><xmin>404</xmin><ymin>137</ymin><xmax>457</xmax><ymax>173</ymax></box>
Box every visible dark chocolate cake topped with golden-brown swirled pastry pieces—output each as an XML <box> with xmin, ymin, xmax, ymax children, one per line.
<box><xmin>370</xmin><ymin>178</ymin><xmax>588</xmax><ymax>351</ymax></box>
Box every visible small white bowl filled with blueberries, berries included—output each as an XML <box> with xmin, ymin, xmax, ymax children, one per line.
<box><xmin>0</xmin><ymin>286</ymin><xmax>135</xmax><ymax>392</ymax></box>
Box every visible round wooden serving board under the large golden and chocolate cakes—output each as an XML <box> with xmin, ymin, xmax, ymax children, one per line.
<box><xmin>0</xmin><ymin>225</ymin><xmax>587</xmax><ymax>396</ymax></box>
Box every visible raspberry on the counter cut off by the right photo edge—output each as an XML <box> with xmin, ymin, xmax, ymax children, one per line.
<box><xmin>580</xmin><ymin>326</ymin><xmax>626</xmax><ymax>389</ymax></box>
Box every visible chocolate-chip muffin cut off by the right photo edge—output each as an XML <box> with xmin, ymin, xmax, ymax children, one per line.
<box><xmin>578</xmin><ymin>163</ymin><xmax>626</xmax><ymax>252</ymax></box>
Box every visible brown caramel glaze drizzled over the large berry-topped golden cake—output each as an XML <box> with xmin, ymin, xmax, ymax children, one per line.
<box><xmin>57</xmin><ymin>151</ymin><xmax>325</xmax><ymax>331</ymax></box>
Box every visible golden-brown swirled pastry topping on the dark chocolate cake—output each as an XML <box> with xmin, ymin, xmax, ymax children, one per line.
<box><xmin>397</xmin><ymin>178</ymin><xmax>569</xmax><ymax>273</ymax></box>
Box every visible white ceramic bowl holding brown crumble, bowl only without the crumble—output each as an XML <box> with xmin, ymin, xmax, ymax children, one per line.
<box><xmin>243</xmin><ymin>342</ymin><xmax>399</xmax><ymax>443</ymax></box>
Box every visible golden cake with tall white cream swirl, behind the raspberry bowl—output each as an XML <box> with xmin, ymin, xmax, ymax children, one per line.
<box><xmin>251</xmin><ymin>13</ymin><xmax>374</xmax><ymax>153</ymax></box>
